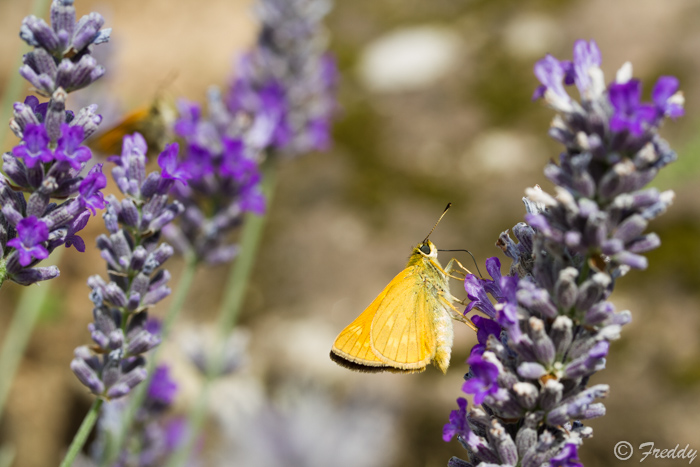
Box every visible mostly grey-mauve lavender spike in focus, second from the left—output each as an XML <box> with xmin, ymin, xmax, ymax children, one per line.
<box><xmin>71</xmin><ymin>133</ymin><xmax>183</xmax><ymax>399</ymax></box>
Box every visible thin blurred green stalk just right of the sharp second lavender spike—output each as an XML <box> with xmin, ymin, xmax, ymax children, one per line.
<box><xmin>101</xmin><ymin>254</ymin><xmax>198</xmax><ymax>466</ymax></box>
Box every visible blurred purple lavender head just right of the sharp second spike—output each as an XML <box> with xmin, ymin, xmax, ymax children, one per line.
<box><xmin>159</xmin><ymin>91</ymin><xmax>265</xmax><ymax>264</ymax></box>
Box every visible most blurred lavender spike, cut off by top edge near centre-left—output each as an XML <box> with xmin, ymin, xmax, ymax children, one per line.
<box><xmin>226</xmin><ymin>0</ymin><xmax>338</xmax><ymax>156</ymax></box>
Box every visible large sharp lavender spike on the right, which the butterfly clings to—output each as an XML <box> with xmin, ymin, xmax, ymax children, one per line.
<box><xmin>443</xmin><ymin>41</ymin><xmax>683</xmax><ymax>467</ymax></box>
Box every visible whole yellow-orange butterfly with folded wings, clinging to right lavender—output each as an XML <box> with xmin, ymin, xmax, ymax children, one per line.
<box><xmin>330</xmin><ymin>204</ymin><xmax>476</xmax><ymax>373</ymax></box>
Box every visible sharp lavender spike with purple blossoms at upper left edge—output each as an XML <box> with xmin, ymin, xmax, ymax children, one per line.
<box><xmin>0</xmin><ymin>0</ymin><xmax>110</xmax><ymax>285</ymax></box>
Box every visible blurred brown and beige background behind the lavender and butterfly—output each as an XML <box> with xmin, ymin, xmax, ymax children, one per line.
<box><xmin>0</xmin><ymin>0</ymin><xmax>700</xmax><ymax>467</ymax></box>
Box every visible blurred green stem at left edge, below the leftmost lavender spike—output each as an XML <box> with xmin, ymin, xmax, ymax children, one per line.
<box><xmin>0</xmin><ymin>248</ymin><xmax>65</xmax><ymax>417</ymax></box>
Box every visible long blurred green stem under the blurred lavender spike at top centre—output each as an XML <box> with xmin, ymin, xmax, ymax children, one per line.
<box><xmin>167</xmin><ymin>160</ymin><xmax>275</xmax><ymax>467</ymax></box>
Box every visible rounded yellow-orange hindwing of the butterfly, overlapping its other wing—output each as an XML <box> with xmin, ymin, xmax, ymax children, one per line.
<box><xmin>370</xmin><ymin>267</ymin><xmax>439</xmax><ymax>372</ymax></box>
